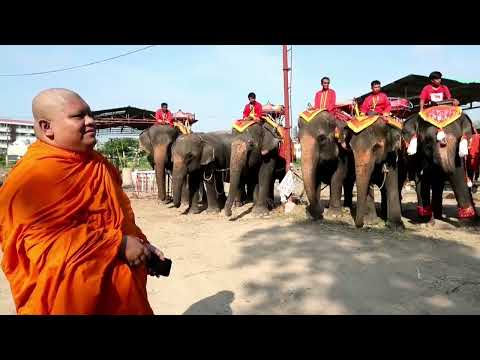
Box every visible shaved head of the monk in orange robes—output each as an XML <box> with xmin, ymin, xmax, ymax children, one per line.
<box><xmin>32</xmin><ymin>89</ymin><xmax>97</xmax><ymax>152</ymax></box>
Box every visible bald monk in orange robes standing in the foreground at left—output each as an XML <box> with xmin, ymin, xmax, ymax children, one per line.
<box><xmin>0</xmin><ymin>89</ymin><xmax>164</xmax><ymax>315</ymax></box>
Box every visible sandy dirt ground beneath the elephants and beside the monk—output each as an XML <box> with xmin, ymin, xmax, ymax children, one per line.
<box><xmin>0</xmin><ymin>189</ymin><xmax>480</xmax><ymax>314</ymax></box>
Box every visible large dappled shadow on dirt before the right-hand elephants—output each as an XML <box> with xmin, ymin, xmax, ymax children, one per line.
<box><xmin>229</xmin><ymin>220</ymin><xmax>480</xmax><ymax>314</ymax></box>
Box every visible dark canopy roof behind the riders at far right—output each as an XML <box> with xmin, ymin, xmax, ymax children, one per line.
<box><xmin>358</xmin><ymin>74</ymin><xmax>480</xmax><ymax>110</ymax></box>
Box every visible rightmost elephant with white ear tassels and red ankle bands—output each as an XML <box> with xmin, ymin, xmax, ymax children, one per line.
<box><xmin>402</xmin><ymin>114</ymin><xmax>477</xmax><ymax>221</ymax></box>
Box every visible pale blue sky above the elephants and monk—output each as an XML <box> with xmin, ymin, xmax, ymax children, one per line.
<box><xmin>0</xmin><ymin>45</ymin><xmax>480</xmax><ymax>131</ymax></box>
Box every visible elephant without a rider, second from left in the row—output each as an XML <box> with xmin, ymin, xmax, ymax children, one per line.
<box><xmin>172</xmin><ymin>132</ymin><xmax>234</xmax><ymax>213</ymax></box>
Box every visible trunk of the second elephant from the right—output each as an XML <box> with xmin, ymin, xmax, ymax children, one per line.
<box><xmin>354</xmin><ymin>153</ymin><xmax>375</xmax><ymax>228</ymax></box>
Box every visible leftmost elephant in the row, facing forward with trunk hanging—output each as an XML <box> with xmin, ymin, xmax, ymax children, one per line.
<box><xmin>139</xmin><ymin>124</ymin><xmax>186</xmax><ymax>204</ymax></box>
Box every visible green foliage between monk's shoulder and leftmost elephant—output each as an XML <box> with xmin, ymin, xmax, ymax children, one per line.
<box><xmin>98</xmin><ymin>138</ymin><xmax>152</xmax><ymax>170</ymax></box>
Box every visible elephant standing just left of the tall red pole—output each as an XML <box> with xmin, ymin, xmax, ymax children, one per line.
<box><xmin>225</xmin><ymin>122</ymin><xmax>281</xmax><ymax>216</ymax></box>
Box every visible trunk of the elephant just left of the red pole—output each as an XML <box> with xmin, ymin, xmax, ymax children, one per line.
<box><xmin>225</xmin><ymin>141</ymin><xmax>247</xmax><ymax>216</ymax></box>
